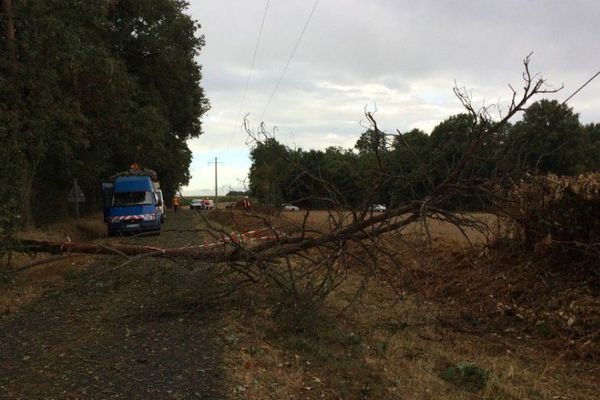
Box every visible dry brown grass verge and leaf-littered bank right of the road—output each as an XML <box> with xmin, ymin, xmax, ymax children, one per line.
<box><xmin>212</xmin><ymin>212</ymin><xmax>600</xmax><ymax>400</ymax></box>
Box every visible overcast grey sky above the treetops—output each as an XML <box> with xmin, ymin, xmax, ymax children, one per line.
<box><xmin>184</xmin><ymin>0</ymin><xmax>600</xmax><ymax>194</ymax></box>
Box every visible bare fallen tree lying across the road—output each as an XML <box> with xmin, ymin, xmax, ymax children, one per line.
<box><xmin>7</xmin><ymin>57</ymin><xmax>556</xmax><ymax>314</ymax></box>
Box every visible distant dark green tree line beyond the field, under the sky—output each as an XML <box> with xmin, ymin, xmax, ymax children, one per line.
<box><xmin>250</xmin><ymin>99</ymin><xmax>600</xmax><ymax>209</ymax></box>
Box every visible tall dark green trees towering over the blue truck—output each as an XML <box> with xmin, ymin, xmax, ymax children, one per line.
<box><xmin>0</xmin><ymin>0</ymin><xmax>209</xmax><ymax>222</ymax></box>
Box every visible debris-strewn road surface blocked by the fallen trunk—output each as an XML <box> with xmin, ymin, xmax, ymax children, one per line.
<box><xmin>0</xmin><ymin>210</ymin><xmax>224</xmax><ymax>399</ymax></box>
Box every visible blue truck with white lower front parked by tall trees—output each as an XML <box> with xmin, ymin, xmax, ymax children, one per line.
<box><xmin>102</xmin><ymin>166</ymin><xmax>164</xmax><ymax>236</ymax></box>
